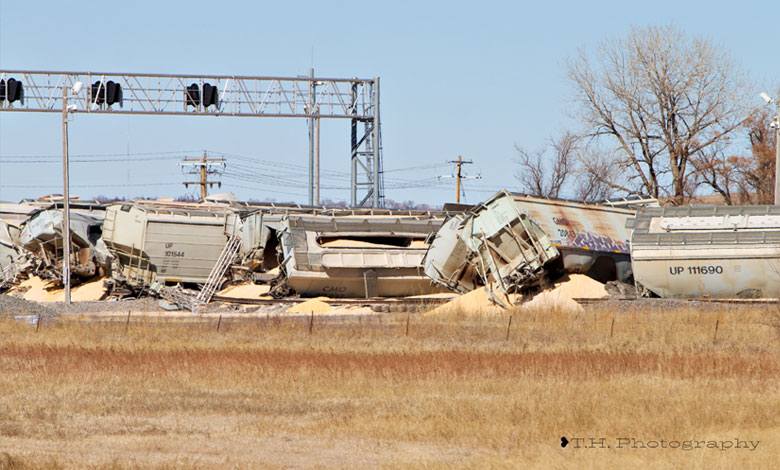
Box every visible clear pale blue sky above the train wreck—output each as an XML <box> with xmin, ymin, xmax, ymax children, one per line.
<box><xmin>0</xmin><ymin>0</ymin><xmax>780</xmax><ymax>204</ymax></box>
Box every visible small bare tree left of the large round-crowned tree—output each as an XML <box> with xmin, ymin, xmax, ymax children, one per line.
<box><xmin>515</xmin><ymin>132</ymin><xmax>577</xmax><ymax>199</ymax></box>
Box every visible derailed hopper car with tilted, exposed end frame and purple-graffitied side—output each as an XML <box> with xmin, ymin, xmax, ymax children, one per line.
<box><xmin>425</xmin><ymin>191</ymin><xmax>635</xmax><ymax>298</ymax></box>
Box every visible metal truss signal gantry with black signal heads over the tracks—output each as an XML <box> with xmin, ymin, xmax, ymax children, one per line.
<box><xmin>0</xmin><ymin>70</ymin><xmax>384</xmax><ymax>207</ymax></box>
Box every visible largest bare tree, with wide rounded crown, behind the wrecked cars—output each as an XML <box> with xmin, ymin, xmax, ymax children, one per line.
<box><xmin>567</xmin><ymin>26</ymin><xmax>746</xmax><ymax>204</ymax></box>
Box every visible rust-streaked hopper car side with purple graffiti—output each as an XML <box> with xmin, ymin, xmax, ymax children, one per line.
<box><xmin>513</xmin><ymin>194</ymin><xmax>636</xmax><ymax>282</ymax></box>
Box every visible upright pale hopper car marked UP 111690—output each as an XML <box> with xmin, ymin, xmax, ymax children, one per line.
<box><xmin>629</xmin><ymin>206</ymin><xmax>780</xmax><ymax>298</ymax></box>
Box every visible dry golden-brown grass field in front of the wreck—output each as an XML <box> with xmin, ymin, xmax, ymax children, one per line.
<box><xmin>0</xmin><ymin>302</ymin><xmax>780</xmax><ymax>470</ymax></box>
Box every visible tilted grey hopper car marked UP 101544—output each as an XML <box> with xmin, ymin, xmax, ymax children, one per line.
<box><xmin>103</xmin><ymin>203</ymin><xmax>240</xmax><ymax>289</ymax></box>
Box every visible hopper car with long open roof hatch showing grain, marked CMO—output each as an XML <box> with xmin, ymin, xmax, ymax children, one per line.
<box><xmin>280</xmin><ymin>215</ymin><xmax>444</xmax><ymax>297</ymax></box>
